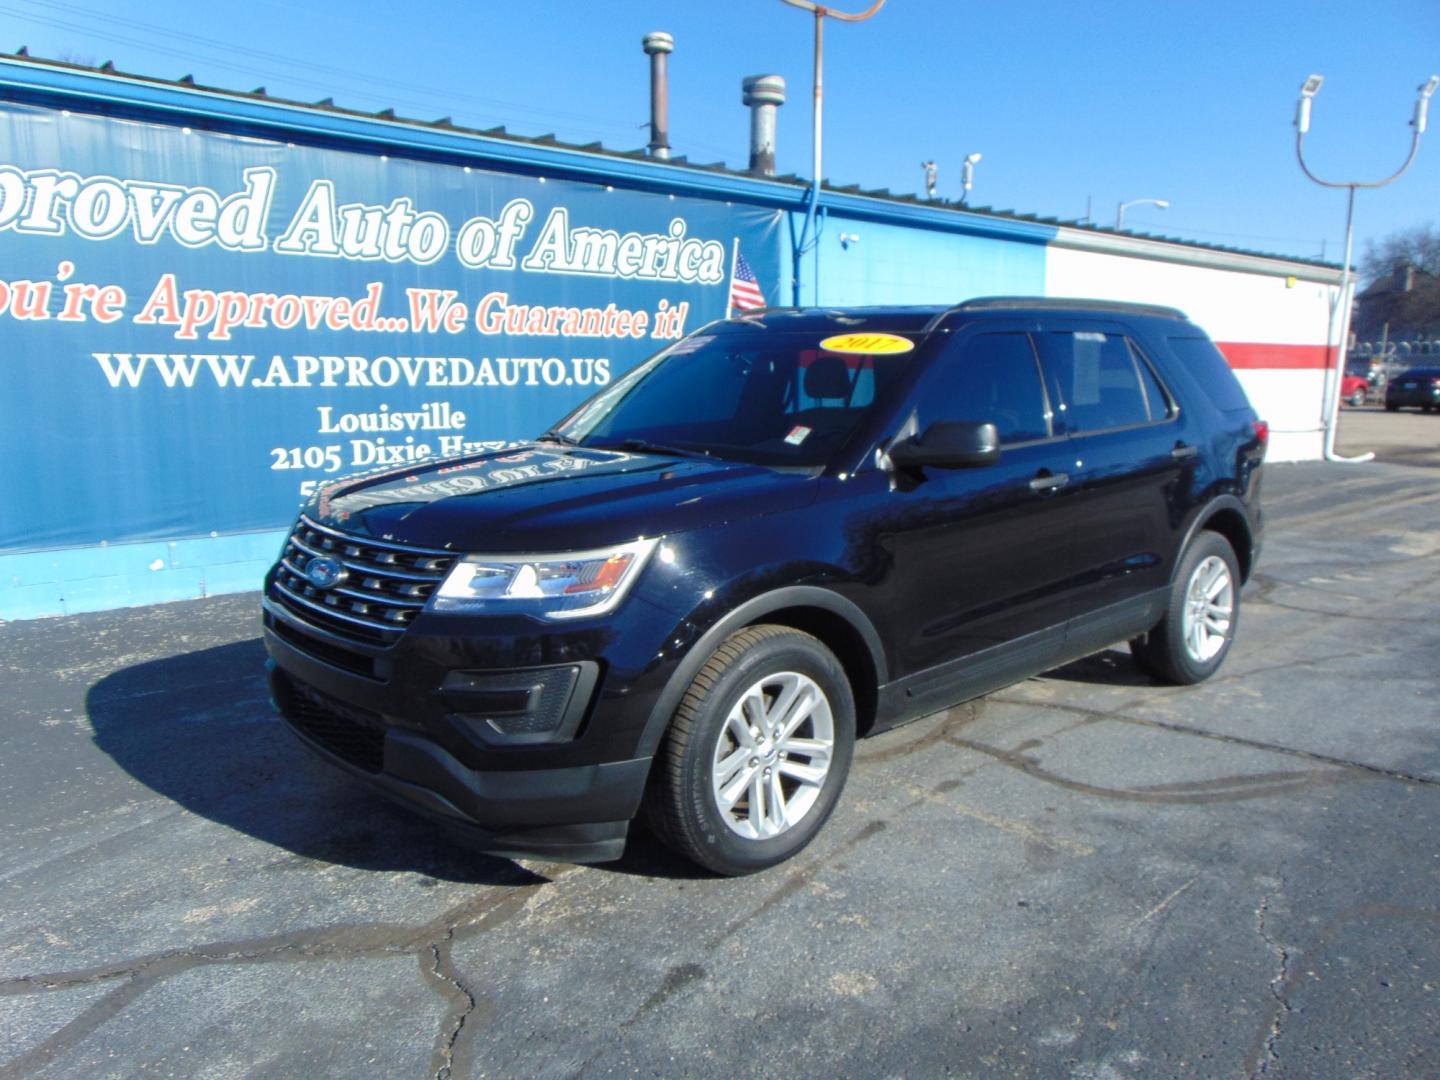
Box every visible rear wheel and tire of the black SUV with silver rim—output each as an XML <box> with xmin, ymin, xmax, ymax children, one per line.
<box><xmin>1130</xmin><ymin>531</ymin><xmax>1240</xmax><ymax>685</ymax></box>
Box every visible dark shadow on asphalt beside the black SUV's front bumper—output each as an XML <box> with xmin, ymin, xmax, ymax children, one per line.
<box><xmin>86</xmin><ymin>638</ymin><xmax>704</xmax><ymax>886</ymax></box>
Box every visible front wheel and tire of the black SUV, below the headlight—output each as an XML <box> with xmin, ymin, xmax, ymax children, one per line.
<box><xmin>645</xmin><ymin>626</ymin><xmax>855</xmax><ymax>876</ymax></box>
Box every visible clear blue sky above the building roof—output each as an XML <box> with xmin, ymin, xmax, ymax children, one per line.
<box><xmin>0</xmin><ymin>0</ymin><xmax>1440</xmax><ymax>269</ymax></box>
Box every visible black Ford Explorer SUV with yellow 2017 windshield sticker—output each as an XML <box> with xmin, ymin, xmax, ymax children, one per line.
<box><xmin>264</xmin><ymin>298</ymin><xmax>1267</xmax><ymax>874</ymax></box>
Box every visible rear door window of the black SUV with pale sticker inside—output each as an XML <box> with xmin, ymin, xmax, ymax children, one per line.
<box><xmin>1038</xmin><ymin>331</ymin><xmax>1164</xmax><ymax>432</ymax></box>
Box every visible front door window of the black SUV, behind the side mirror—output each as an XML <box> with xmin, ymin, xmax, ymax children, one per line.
<box><xmin>920</xmin><ymin>334</ymin><xmax>1050</xmax><ymax>442</ymax></box>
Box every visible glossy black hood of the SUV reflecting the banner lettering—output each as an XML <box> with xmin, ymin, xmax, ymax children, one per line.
<box><xmin>305</xmin><ymin>444</ymin><xmax>816</xmax><ymax>553</ymax></box>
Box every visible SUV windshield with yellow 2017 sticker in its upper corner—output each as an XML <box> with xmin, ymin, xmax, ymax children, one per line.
<box><xmin>552</xmin><ymin>328</ymin><xmax>914</xmax><ymax>467</ymax></box>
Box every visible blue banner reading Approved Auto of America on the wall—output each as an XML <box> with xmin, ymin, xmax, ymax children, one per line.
<box><xmin>0</xmin><ymin>104</ymin><xmax>782</xmax><ymax>552</ymax></box>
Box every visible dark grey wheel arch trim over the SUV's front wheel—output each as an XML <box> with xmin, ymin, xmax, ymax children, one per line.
<box><xmin>638</xmin><ymin>585</ymin><xmax>888</xmax><ymax>756</ymax></box>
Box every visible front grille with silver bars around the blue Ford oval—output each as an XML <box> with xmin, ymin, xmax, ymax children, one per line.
<box><xmin>274</xmin><ymin>516</ymin><xmax>456</xmax><ymax>645</ymax></box>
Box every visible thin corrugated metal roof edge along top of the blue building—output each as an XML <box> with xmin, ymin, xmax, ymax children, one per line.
<box><xmin>2</xmin><ymin>46</ymin><xmax>1339</xmax><ymax>271</ymax></box>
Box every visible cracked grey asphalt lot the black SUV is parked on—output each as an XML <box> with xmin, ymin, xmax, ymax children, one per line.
<box><xmin>0</xmin><ymin>455</ymin><xmax>1440</xmax><ymax>1080</ymax></box>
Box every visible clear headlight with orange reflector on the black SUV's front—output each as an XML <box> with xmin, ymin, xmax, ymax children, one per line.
<box><xmin>433</xmin><ymin>540</ymin><xmax>660</xmax><ymax>619</ymax></box>
